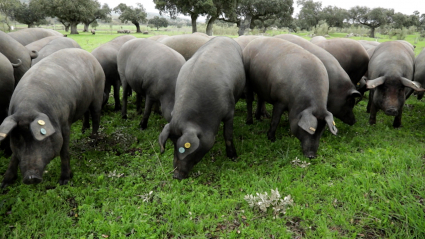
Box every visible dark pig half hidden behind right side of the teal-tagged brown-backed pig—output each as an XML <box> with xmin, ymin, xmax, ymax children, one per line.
<box><xmin>275</xmin><ymin>34</ymin><xmax>361</xmax><ymax>125</ymax></box>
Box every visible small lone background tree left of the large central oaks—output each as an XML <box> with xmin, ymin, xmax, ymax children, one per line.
<box><xmin>114</xmin><ymin>3</ymin><xmax>147</xmax><ymax>32</ymax></box>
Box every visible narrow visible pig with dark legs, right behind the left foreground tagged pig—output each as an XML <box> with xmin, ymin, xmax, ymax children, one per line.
<box><xmin>91</xmin><ymin>35</ymin><xmax>136</xmax><ymax>111</ymax></box>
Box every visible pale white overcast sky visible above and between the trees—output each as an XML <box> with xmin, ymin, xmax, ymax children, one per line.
<box><xmin>99</xmin><ymin>0</ymin><xmax>425</xmax><ymax>21</ymax></box>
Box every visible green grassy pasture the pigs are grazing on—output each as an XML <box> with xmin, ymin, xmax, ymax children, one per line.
<box><xmin>0</xmin><ymin>31</ymin><xmax>425</xmax><ymax>238</ymax></box>
